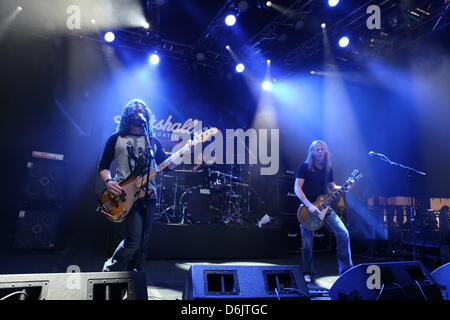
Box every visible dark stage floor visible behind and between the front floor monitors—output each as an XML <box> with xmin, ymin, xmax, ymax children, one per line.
<box><xmin>0</xmin><ymin>248</ymin><xmax>384</xmax><ymax>300</ymax></box>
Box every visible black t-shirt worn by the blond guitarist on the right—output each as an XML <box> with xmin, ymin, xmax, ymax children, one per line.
<box><xmin>295</xmin><ymin>162</ymin><xmax>334</xmax><ymax>202</ymax></box>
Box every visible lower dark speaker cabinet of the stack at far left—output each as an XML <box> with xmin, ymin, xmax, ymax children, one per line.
<box><xmin>14</xmin><ymin>208</ymin><xmax>62</xmax><ymax>249</ymax></box>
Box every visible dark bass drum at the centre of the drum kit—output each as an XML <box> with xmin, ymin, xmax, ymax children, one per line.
<box><xmin>180</xmin><ymin>185</ymin><xmax>225</xmax><ymax>224</ymax></box>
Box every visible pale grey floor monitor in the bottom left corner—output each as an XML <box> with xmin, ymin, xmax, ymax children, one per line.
<box><xmin>0</xmin><ymin>272</ymin><xmax>148</xmax><ymax>300</ymax></box>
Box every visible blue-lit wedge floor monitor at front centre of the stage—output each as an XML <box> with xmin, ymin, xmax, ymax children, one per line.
<box><xmin>183</xmin><ymin>264</ymin><xmax>309</xmax><ymax>300</ymax></box>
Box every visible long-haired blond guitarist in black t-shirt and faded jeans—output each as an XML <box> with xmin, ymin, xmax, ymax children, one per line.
<box><xmin>294</xmin><ymin>140</ymin><xmax>353</xmax><ymax>282</ymax></box>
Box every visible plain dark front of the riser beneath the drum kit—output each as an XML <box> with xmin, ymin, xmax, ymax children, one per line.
<box><xmin>149</xmin><ymin>223</ymin><xmax>288</xmax><ymax>259</ymax></box>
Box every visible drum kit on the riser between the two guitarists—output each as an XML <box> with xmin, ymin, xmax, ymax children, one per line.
<box><xmin>155</xmin><ymin>165</ymin><xmax>254</xmax><ymax>224</ymax></box>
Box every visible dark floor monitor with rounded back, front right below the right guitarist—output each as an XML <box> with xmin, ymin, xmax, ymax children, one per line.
<box><xmin>330</xmin><ymin>261</ymin><xmax>443</xmax><ymax>300</ymax></box>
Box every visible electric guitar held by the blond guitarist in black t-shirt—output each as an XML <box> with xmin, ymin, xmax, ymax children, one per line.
<box><xmin>297</xmin><ymin>170</ymin><xmax>362</xmax><ymax>231</ymax></box>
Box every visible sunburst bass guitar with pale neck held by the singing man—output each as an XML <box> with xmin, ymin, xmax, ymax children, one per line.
<box><xmin>97</xmin><ymin>128</ymin><xmax>218</xmax><ymax>222</ymax></box>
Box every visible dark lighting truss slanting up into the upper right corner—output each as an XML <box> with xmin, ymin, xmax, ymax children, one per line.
<box><xmin>282</xmin><ymin>0</ymin><xmax>449</xmax><ymax>66</ymax></box>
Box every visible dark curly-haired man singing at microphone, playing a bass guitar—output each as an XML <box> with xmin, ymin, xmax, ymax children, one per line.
<box><xmin>98</xmin><ymin>99</ymin><xmax>173</xmax><ymax>271</ymax></box>
